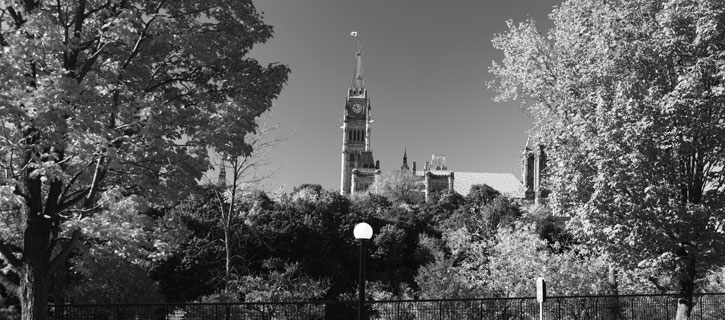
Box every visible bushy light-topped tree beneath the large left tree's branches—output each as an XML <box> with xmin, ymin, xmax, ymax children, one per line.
<box><xmin>60</xmin><ymin>188</ymin><xmax>189</xmax><ymax>304</ymax></box>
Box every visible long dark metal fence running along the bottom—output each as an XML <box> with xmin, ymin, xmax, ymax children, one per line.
<box><xmin>49</xmin><ymin>294</ymin><xmax>725</xmax><ymax>320</ymax></box>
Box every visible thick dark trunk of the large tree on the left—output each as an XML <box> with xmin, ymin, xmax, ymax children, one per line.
<box><xmin>19</xmin><ymin>218</ymin><xmax>50</xmax><ymax>320</ymax></box>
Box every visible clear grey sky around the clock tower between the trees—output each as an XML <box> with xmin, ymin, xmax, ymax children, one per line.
<box><xmin>245</xmin><ymin>0</ymin><xmax>561</xmax><ymax>190</ymax></box>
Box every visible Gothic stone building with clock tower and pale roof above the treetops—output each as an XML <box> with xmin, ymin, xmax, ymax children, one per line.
<box><xmin>340</xmin><ymin>45</ymin><xmax>546</xmax><ymax>203</ymax></box>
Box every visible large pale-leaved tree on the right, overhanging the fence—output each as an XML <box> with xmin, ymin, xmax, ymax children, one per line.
<box><xmin>490</xmin><ymin>0</ymin><xmax>725</xmax><ymax>320</ymax></box>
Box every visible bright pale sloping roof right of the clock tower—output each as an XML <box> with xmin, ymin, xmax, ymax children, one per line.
<box><xmin>453</xmin><ymin>171</ymin><xmax>524</xmax><ymax>198</ymax></box>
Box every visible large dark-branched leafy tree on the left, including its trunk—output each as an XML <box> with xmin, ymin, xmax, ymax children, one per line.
<box><xmin>0</xmin><ymin>0</ymin><xmax>289</xmax><ymax>320</ymax></box>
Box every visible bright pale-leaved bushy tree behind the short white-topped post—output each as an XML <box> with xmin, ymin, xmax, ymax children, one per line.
<box><xmin>470</xmin><ymin>224</ymin><xmax>607</xmax><ymax>297</ymax></box>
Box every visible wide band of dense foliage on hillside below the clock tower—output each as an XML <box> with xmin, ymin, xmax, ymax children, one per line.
<box><xmin>147</xmin><ymin>185</ymin><xmax>624</xmax><ymax>302</ymax></box>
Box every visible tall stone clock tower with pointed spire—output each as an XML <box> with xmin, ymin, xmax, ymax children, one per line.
<box><xmin>340</xmin><ymin>45</ymin><xmax>380</xmax><ymax>195</ymax></box>
